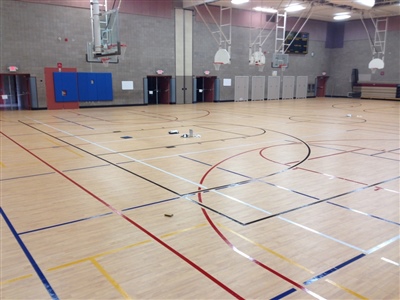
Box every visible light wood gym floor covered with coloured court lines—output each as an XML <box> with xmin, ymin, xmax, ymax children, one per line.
<box><xmin>0</xmin><ymin>98</ymin><xmax>400</xmax><ymax>299</ymax></box>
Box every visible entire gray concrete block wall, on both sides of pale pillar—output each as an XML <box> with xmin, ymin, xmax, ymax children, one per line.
<box><xmin>0</xmin><ymin>1</ymin><xmax>400</xmax><ymax>108</ymax></box>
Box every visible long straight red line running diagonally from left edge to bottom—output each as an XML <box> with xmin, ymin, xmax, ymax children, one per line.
<box><xmin>0</xmin><ymin>131</ymin><xmax>245</xmax><ymax>300</ymax></box>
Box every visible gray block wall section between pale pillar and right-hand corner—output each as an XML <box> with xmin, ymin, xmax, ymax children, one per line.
<box><xmin>193</xmin><ymin>22</ymin><xmax>331</xmax><ymax>101</ymax></box>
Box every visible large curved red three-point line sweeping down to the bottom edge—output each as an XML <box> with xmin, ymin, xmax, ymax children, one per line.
<box><xmin>197</xmin><ymin>147</ymin><xmax>324</xmax><ymax>299</ymax></box>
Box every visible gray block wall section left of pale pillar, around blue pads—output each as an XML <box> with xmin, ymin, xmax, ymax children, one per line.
<box><xmin>0</xmin><ymin>1</ymin><xmax>175</xmax><ymax>108</ymax></box>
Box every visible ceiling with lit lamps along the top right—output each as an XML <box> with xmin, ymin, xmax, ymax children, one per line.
<box><xmin>183</xmin><ymin>0</ymin><xmax>400</xmax><ymax>22</ymax></box>
